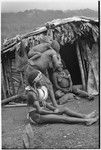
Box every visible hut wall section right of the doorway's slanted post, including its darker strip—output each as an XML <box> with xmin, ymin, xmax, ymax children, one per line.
<box><xmin>82</xmin><ymin>41</ymin><xmax>99</xmax><ymax>95</ymax></box>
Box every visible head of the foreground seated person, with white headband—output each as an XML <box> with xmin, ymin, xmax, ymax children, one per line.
<box><xmin>28</xmin><ymin>69</ymin><xmax>42</xmax><ymax>86</ymax></box>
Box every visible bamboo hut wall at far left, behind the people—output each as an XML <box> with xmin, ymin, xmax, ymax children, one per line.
<box><xmin>1</xmin><ymin>52</ymin><xmax>24</xmax><ymax>99</ymax></box>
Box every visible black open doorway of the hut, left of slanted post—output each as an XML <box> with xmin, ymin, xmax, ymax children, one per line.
<box><xmin>60</xmin><ymin>44</ymin><xmax>82</xmax><ymax>85</ymax></box>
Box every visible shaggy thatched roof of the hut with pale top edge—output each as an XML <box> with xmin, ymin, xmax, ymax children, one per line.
<box><xmin>1</xmin><ymin>17</ymin><xmax>99</xmax><ymax>54</ymax></box>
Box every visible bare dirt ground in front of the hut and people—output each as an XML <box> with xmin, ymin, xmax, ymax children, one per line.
<box><xmin>2</xmin><ymin>96</ymin><xmax>99</xmax><ymax>149</ymax></box>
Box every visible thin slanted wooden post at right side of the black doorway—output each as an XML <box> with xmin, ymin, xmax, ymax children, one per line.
<box><xmin>76</xmin><ymin>43</ymin><xmax>86</xmax><ymax>90</ymax></box>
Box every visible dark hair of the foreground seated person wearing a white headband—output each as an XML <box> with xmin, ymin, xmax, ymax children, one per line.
<box><xmin>27</xmin><ymin>69</ymin><xmax>39</xmax><ymax>86</ymax></box>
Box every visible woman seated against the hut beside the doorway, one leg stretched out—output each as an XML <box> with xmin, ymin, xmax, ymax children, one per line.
<box><xmin>52</xmin><ymin>65</ymin><xmax>93</xmax><ymax>100</ymax></box>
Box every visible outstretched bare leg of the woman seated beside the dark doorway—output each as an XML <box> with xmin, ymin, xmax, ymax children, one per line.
<box><xmin>72</xmin><ymin>86</ymin><xmax>94</xmax><ymax>100</ymax></box>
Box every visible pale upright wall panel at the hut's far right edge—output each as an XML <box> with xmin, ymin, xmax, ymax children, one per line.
<box><xmin>86</xmin><ymin>44</ymin><xmax>99</xmax><ymax>95</ymax></box>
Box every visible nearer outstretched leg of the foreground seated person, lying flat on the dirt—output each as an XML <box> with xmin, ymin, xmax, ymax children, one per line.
<box><xmin>39</xmin><ymin>114</ymin><xmax>98</xmax><ymax>125</ymax></box>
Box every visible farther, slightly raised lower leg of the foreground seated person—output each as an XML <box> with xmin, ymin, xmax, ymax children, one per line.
<box><xmin>58</xmin><ymin>106</ymin><xmax>96</xmax><ymax>118</ymax></box>
